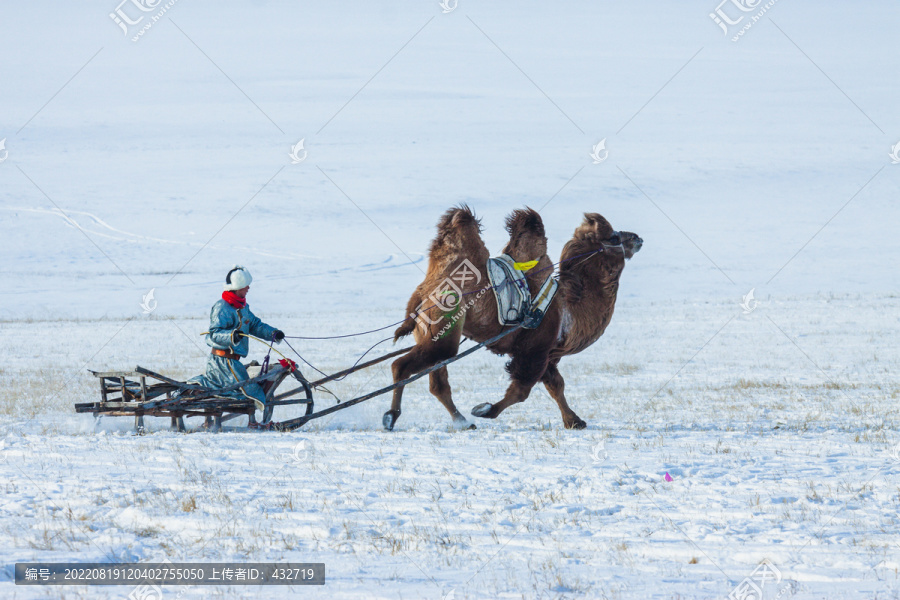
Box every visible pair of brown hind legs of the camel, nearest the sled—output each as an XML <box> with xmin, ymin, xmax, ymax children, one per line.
<box><xmin>382</xmin><ymin>326</ymin><xmax>465</xmax><ymax>431</ymax></box>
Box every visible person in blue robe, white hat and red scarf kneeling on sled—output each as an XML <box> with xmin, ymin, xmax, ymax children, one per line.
<box><xmin>188</xmin><ymin>265</ymin><xmax>284</xmax><ymax>422</ymax></box>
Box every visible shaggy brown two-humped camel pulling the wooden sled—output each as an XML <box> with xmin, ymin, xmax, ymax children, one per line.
<box><xmin>383</xmin><ymin>205</ymin><xmax>643</xmax><ymax>430</ymax></box>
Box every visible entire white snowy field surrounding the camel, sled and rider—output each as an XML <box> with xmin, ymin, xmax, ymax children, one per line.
<box><xmin>0</xmin><ymin>0</ymin><xmax>900</xmax><ymax>600</ymax></box>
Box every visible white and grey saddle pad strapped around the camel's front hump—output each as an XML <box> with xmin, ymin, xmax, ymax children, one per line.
<box><xmin>487</xmin><ymin>254</ymin><xmax>559</xmax><ymax>329</ymax></box>
